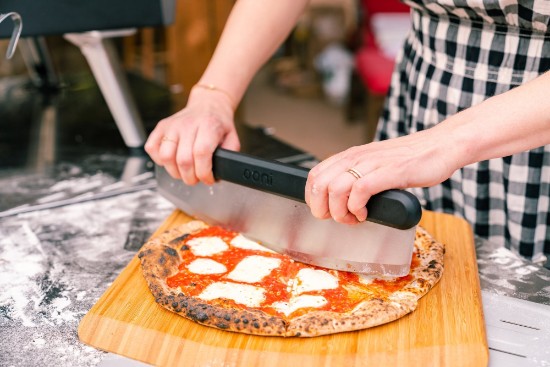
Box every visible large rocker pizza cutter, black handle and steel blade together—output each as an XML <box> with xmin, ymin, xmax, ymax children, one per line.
<box><xmin>156</xmin><ymin>148</ymin><xmax>422</xmax><ymax>276</ymax></box>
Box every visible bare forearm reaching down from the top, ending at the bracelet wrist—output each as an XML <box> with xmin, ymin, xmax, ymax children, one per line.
<box><xmin>199</xmin><ymin>0</ymin><xmax>308</xmax><ymax>108</ymax></box>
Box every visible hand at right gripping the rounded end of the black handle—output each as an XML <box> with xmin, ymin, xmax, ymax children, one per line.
<box><xmin>305</xmin><ymin>129</ymin><xmax>461</xmax><ymax>224</ymax></box>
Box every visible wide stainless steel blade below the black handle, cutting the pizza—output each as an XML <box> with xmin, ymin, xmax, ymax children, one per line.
<box><xmin>156</xmin><ymin>167</ymin><xmax>416</xmax><ymax>276</ymax></box>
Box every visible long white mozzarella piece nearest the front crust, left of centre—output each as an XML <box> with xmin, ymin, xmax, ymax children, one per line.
<box><xmin>198</xmin><ymin>282</ymin><xmax>265</xmax><ymax>307</ymax></box>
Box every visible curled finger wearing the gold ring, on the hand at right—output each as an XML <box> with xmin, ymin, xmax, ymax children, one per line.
<box><xmin>328</xmin><ymin>171</ymin><xmax>357</xmax><ymax>224</ymax></box>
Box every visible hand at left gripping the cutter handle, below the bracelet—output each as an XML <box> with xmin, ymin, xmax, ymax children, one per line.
<box><xmin>145</xmin><ymin>87</ymin><xmax>240</xmax><ymax>185</ymax></box>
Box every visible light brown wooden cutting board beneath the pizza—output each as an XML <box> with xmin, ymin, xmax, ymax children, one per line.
<box><xmin>78</xmin><ymin>210</ymin><xmax>488</xmax><ymax>367</ymax></box>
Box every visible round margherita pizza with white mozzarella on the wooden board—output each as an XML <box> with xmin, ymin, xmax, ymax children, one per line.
<box><xmin>138</xmin><ymin>220</ymin><xmax>444</xmax><ymax>337</ymax></box>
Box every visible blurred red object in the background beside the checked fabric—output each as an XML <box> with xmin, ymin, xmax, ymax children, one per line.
<box><xmin>355</xmin><ymin>0</ymin><xmax>410</xmax><ymax>95</ymax></box>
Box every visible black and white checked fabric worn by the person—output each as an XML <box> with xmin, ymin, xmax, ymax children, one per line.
<box><xmin>377</xmin><ymin>0</ymin><xmax>550</xmax><ymax>261</ymax></box>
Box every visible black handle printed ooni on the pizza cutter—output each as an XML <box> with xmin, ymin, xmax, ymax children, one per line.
<box><xmin>212</xmin><ymin>148</ymin><xmax>422</xmax><ymax>229</ymax></box>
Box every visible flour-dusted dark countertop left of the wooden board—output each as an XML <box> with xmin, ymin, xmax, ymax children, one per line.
<box><xmin>0</xmin><ymin>190</ymin><xmax>174</xmax><ymax>366</ymax></box>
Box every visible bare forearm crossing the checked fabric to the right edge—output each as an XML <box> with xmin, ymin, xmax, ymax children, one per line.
<box><xmin>440</xmin><ymin>73</ymin><xmax>550</xmax><ymax>168</ymax></box>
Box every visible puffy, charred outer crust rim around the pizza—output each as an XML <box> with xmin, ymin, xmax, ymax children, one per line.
<box><xmin>138</xmin><ymin>221</ymin><xmax>444</xmax><ymax>337</ymax></box>
